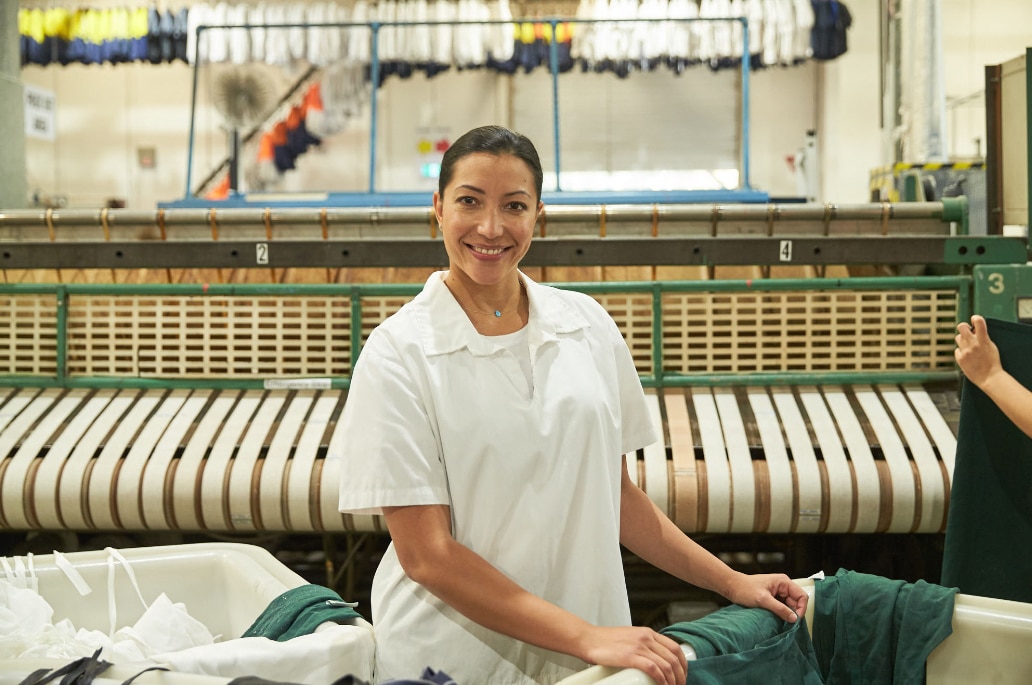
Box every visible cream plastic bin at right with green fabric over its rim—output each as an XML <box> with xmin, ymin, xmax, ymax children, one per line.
<box><xmin>558</xmin><ymin>579</ymin><xmax>1032</xmax><ymax>685</ymax></box>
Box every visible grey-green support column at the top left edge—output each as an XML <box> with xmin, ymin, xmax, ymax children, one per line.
<box><xmin>0</xmin><ymin>2</ymin><xmax>29</xmax><ymax>209</ymax></box>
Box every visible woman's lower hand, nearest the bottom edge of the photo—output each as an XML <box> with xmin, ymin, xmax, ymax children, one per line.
<box><xmin>585</xmin><ymin>626</ymin><xmax>688</xmax><ymax>685</ymax></box>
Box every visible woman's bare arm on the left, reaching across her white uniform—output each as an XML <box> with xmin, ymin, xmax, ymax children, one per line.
<box><xmin>384</xmin><ymin>505</ymin><xmax>687</xmax><ymax>685</ymax></box>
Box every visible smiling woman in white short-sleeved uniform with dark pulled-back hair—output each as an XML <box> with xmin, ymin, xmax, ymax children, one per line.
<box><xmin>340</xmin><ymin>126</ymin><xmax>806</xmax><ymax>685</ymax></box>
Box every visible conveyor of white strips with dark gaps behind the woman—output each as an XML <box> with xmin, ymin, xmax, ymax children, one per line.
<box><xmin>0</xmin><ymin>385</ymin><xmax>957</xmax><ymax>533</ymax></box>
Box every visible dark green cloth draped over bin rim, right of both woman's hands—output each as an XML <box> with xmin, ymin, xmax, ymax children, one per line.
<box><xmin>813</xmin><ymin>569</ymin><xmax>957</xmax><ymax>685</ymax></box>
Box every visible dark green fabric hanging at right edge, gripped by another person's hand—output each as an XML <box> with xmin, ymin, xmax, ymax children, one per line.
<box><xmin>942</xmin><ymin>319</ymin><xmax>1032</xmax><ymax>602</ymax></box>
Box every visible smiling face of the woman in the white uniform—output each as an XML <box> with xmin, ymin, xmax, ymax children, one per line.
<box><xmin>433</xmin><ymin>153</ymin><xmax>543</xmax><ymax>286</ymax></box>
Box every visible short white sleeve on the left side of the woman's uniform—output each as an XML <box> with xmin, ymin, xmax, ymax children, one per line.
<box><xmin>336</xmin><ymin>332</ymin><xmax>451</xmax><ymax>514</ymax></box>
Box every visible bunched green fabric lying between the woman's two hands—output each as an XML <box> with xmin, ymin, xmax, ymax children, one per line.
<box><xmin>660</xmin><ymin>606</ymin><xmax>821</xmax><ymax>685</ymax></box>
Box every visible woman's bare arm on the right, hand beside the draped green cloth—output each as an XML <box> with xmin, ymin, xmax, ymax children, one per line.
<box><xmin>620</xmin><ymin>457</ymin><xmax>807</xmax><ymax>623</ymax></box>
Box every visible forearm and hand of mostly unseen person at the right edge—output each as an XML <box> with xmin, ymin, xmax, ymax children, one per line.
<box><xmin>954</xmin><ymin>315</ymin><xmax>1032</xmax><ymax>437</ymax></box>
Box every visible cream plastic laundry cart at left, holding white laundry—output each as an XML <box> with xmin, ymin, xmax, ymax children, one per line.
<box><xmin>0</xmin><ymin>543</ymin><xmax>375</xmax><ymax>685</ymax></box>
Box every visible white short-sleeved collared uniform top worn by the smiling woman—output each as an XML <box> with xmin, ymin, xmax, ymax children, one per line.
<box><xmin>342</xmin><ymin>272</ymin><xmax>655</xmax><ymax>685</ymax></box>
